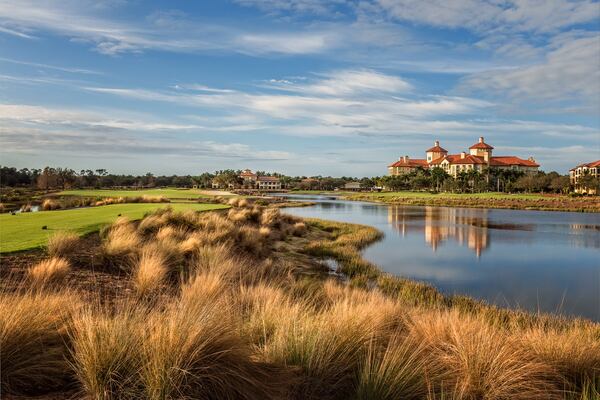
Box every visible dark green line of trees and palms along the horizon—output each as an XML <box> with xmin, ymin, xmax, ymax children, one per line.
<box><xmin>0</xmin><ymin>166</ymin><xmax>580</xmax><ymax>193</ymax></box>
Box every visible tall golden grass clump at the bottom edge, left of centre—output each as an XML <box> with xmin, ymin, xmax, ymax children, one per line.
<box><xmin>141</xmin><ymin>277</ymin><xmax>286</xmax><ymax>399</ymax></box>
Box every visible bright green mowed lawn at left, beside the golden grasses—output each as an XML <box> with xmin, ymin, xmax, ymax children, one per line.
<box><xmin>0</xmin><ymin>203</ymin><xmax>228</xmax><ymax>253</ymax></box>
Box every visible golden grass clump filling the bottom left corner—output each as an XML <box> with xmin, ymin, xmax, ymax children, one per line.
<box><xmin>0</xmin><ymin>291</ymin><xmax>77</xmax><ymax>394</ymax></box>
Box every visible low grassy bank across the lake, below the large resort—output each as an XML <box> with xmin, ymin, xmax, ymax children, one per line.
<box><xmin>344</xmin><ymin>192</ymin><xmax>600</xmax><ymax>212</ymax></box>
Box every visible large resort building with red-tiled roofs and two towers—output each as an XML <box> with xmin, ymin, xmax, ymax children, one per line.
<box><xmin>388</xmin><ymin>136</ymin><xmax>539</xmax><ymax>178</ymax></box>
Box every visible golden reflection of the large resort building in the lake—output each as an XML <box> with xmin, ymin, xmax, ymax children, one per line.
<box><xmin>388</xmin><ymin>206</ymin><xmax>490</xmax><ymax>257</ymax></box>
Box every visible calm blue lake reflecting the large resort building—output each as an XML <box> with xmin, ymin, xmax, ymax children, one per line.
<box><xmin>284</xmin><ymin>195</ymin><xmax>600</xmax><ymax>321</ymax></box>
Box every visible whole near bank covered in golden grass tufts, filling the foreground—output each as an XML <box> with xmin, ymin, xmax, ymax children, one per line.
<box><xmin>0</xmin><ymin>205</ymin><xmax>600</xmax><ymax>400</ymax></box>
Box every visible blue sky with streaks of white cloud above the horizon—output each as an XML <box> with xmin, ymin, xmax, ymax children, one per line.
<box><xmin>0</xmin><ymin>0</ymin><xmax>600</xmax><ymax>176</ymax></box>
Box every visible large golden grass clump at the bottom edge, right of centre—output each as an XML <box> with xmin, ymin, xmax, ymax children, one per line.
<box><xmin>408</xmin><ymin>311</ymin><xmax>561</xmax><ymax>400</ymax></box>
